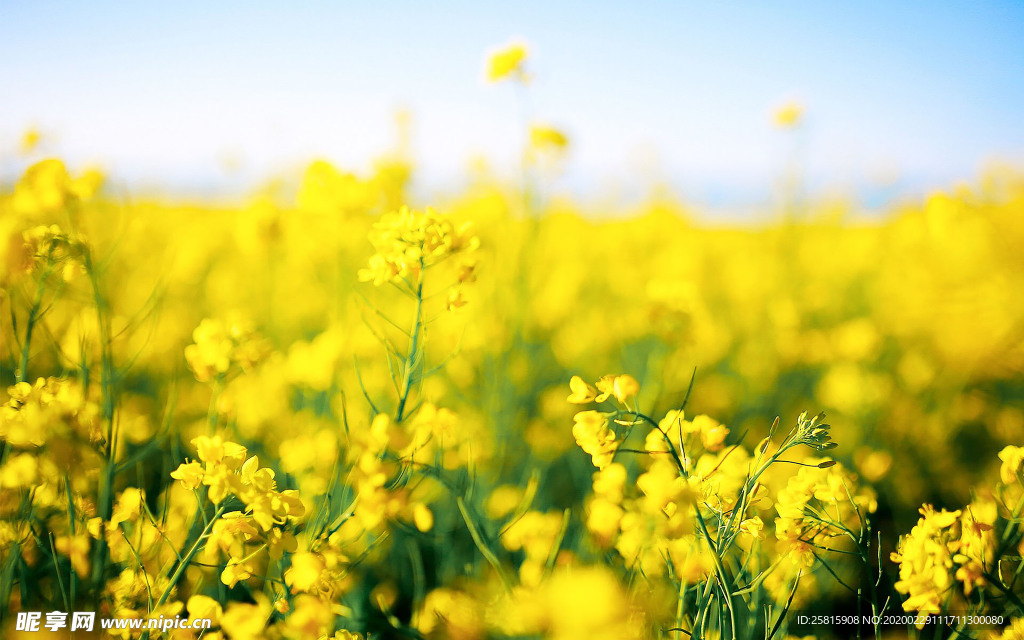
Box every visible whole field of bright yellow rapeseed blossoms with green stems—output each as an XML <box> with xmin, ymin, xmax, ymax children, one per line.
<box><xmin>0</xmin><ymin>42</ymin><xmax>1024</xmax><ymax>640</ymax></box>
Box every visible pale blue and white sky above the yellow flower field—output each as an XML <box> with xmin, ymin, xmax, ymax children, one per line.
<box><xmin>0</xmin><ymin>0</ymin><xmax>1024</xmax><ymax>204</ymax></box>
